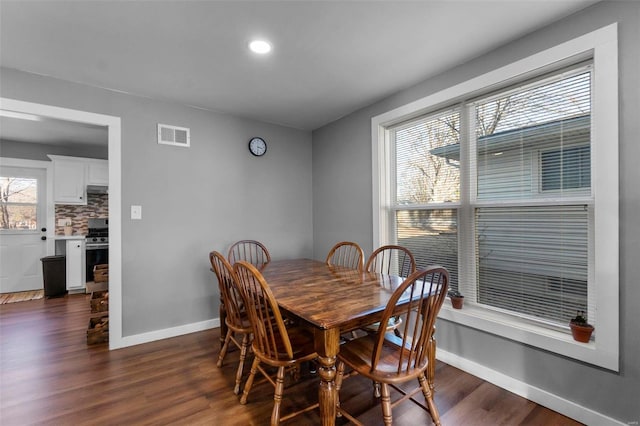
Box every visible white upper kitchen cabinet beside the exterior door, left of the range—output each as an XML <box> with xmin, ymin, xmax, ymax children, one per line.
<box><xmin>49</xmin><ymin>155</ymin><xmax>87</xmax><ymax>205</ymax></box>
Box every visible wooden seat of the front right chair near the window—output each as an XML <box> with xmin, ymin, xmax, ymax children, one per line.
<box><xmin>338</xmin><ymin>334</ymin><xmax>427</xmax><ymax>383</ymax></box>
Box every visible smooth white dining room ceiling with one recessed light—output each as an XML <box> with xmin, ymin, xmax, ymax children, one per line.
<box><xmin>0</xmin><ymin>0</ymin><xmax>596</xmax><ymax>138</ymax></box>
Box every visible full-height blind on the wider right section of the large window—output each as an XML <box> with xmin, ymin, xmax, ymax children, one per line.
<box><xmin>471</xmin><ymin>67</ymin><xmax>594</xmax><ymax>326</ymax></box>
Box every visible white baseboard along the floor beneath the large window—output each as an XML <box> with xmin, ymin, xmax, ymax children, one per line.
<box><xmin>436</xmin><ymin>348</ymin><xmax>625</xmax><ymax>426</ymax></box>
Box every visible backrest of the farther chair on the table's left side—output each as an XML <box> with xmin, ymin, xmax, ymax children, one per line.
<box><xmin>209</xmin><ymin>251</ymin><xmax>246</xmax><ymax>328</ymax></box>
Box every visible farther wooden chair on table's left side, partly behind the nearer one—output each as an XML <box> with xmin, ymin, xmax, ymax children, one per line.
<box><xmin>209</xmin><ymin>251</ymin><xmax>253</xmax><ymax>395</ymax></box>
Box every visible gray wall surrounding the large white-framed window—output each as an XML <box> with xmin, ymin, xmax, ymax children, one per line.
<box><xmin>313</xmin><ymin>1</ymin><xmax>640</xmax><ymax>424</ymax></box>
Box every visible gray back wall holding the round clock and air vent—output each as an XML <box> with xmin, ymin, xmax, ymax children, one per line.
<box><xmin>0</xmin><ymin>69</ymin><xmax>313</xmax><ymax>337</ymax></box>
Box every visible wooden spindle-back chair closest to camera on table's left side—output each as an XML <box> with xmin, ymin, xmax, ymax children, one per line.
<box><xmin>233</xmin><ymin>261</ymin><xmax>318</xmax><ymax>425</ymax></box>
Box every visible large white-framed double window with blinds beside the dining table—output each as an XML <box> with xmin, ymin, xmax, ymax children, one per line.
<box><xmin>373</xmin><ymin>24</ymin><xmax>618</xmax><ymax>369</ymax></box>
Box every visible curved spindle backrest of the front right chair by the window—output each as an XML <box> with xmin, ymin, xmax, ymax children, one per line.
<box><xmin>371</xmin><ymin>266</ymin><xmax>449</xmax><ymax>375</ymax></box>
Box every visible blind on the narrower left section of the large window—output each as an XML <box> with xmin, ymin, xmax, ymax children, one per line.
<box><xmin>391</xmin><ymin>109</ymin><xmax>460</xmax><ymax>288</ymax></box>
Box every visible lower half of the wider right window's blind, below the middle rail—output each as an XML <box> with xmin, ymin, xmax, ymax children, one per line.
<box><xmin>476</xmin><ymin>206</ymin><xmax>588</xmax><ymax>325</ymax></box>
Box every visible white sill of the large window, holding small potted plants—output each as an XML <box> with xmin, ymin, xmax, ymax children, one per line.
<box><xmin>438</xmin><ymin>301</ymin><xmax>618</xmax><ymax>371</ymax></box>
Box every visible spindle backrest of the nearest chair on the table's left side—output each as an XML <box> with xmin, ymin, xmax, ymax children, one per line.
<box><xmin>233</xmin><ymin>260</ymin><xmax>293</xmax><ymax>361</ymax></box>
